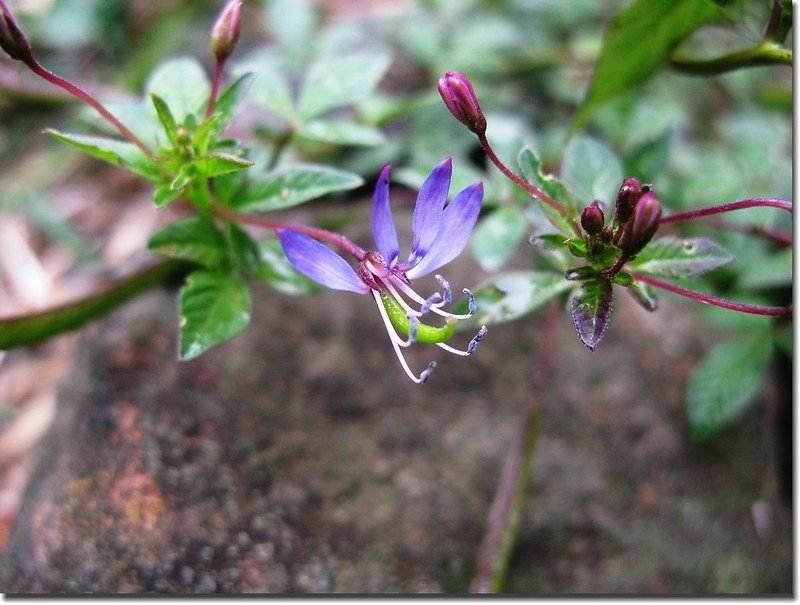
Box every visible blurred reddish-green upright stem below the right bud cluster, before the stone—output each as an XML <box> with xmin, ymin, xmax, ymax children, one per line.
<box><xmin>472</xmin><ymin>301</ymin><xmax>558</xmax><ymax>593</ymax></box>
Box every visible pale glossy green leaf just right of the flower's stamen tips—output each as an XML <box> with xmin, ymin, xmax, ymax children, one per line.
<box><xmin>456</xmin><ymin>271</ymin><xmax>574</xmax><ymax>324</ymax></box>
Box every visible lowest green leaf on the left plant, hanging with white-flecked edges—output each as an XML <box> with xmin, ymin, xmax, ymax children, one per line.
<box><xmin>179</xmin><ymin>270</ymin><xmax>251</xmax><ymax>360</ymax></box>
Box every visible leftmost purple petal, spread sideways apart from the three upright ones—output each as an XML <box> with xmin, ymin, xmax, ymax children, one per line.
<box><xmin>278</xmin><ymin>229</ymin><xmax>369</xmax><ymax>294</ymax></box>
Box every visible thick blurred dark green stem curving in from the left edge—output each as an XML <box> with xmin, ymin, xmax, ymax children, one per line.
<box><xmin>0</xmin><ymin>260</ymin><xmax>194</xmax><ymax>350</ymax></box>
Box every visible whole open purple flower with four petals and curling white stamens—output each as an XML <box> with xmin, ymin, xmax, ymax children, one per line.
<box><xmin>278</xmin><ymin>158</ymin><xmax>486</xmax><ymax>382</ymax></box>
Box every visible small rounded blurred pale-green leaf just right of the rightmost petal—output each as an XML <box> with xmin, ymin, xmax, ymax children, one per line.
<box><xmin>472</xmin><ymin>207</ymin><xmax>529</xmax><ymax>272</ymax></box>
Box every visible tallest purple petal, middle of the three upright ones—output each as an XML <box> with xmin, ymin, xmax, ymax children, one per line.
<box><xmin>405</xmin><ymin>158</ymin><xmax>453</xmax><ymax>266</ymax></box>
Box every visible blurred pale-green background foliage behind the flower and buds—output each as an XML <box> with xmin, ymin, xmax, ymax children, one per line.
<box><xmin>0</xmin><ymin>0</ymin><xmax>792</xmax><ymax>437</ymax></box>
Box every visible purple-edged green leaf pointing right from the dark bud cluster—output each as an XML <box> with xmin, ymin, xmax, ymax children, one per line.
<box><xmin>630</xmin><ymin>237</ymin><xmax>733</xmax><ymax>279</ymax></box>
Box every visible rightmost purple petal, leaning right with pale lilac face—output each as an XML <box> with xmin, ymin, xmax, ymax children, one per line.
<box><xmin>406</xmin><ymin>183</ymin><xmax>483</xmax><ymax>279</ymax></box>
